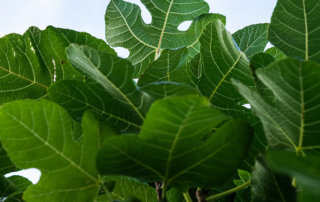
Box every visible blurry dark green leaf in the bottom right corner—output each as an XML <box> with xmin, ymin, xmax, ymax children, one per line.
<box><xmin>267</xmin><ymin>151</ymin><xmax>320</xmax><ymax>202</ymax></box>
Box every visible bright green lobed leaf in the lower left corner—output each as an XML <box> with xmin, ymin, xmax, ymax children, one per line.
<box><xmin>0</xmin><ymin>100</ymin><xmax>109</xmax><ymax>202</ymax></box>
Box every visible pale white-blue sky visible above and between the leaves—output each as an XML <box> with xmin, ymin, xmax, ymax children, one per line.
<box><xmin>0</xmin><ymin>0</ymin><xmax>276</xmax><ymax>183</ymax></box>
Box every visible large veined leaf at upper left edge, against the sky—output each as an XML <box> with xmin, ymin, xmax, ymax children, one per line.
<box><xmin>0</xmin><ymin>26</ymin><xmax>114</xmax><ymax>104</ymax></box>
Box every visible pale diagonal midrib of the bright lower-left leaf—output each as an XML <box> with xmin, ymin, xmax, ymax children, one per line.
<box><xmin>4</xmin><ymin>110</ymin><xmax>99</xmax><ymax>184</ymax></box>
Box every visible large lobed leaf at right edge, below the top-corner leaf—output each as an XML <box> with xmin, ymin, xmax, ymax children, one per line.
<box><xmin>235</xmin><ymin>59</ymin><xmax>320</xmax><ymax>152</ymax></box>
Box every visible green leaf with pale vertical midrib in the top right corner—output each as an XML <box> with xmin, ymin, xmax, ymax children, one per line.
<box><xmin>268</xmin><ymin>0</ymin><xmax>320</xmax><ymax>62</ymax></box>
